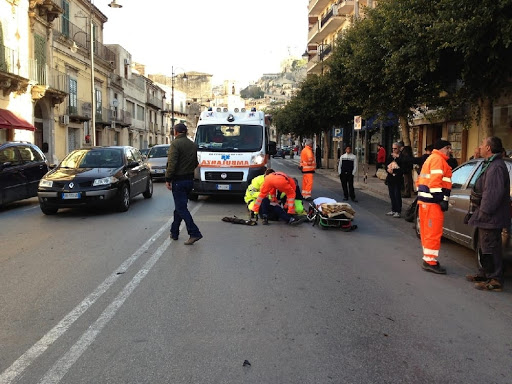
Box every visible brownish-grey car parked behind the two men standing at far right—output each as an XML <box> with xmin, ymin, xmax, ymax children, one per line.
<box><xmin>415</xmin><ymin>158</ymin><xmax>512</xmax><ymax>257</ymax></box>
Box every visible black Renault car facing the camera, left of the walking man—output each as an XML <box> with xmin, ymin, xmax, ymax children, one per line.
<box><xmin>37</xmin><ymin>146</ymin><xmax>153</xmax><ymax>215</ymax></box>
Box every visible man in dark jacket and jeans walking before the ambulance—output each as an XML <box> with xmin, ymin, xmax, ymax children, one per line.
<box><xmin>165</xmin><ymin>123</ymin><xmax>203</xmax><ymax>245</ymax></box>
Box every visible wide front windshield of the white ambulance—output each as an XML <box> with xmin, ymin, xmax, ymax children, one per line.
<box><xmin>195</xmin><ymin>124</ymin><xmax>263</xmax><ymax>152</ymax></box>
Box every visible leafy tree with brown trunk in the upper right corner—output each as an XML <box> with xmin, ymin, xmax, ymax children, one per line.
<box><xmin>433</xmin><ymin>0</ymin><xmax>512</xmax><ymax>136</ymax></box>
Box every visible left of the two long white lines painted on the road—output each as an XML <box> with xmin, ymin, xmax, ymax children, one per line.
<box><xmin>0</xmin><ymin>203</ymin><xmax>202</xmax><ymax>384</ymax></box>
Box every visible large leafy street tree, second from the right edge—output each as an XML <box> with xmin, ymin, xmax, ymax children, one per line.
<box><xmin>331</xmin><ymin>0</ymin><xmax>452</xmax><ymax>145</ymax></box>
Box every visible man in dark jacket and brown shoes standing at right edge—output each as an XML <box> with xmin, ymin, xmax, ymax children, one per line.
<box><xmin>466</xmin><ymin>137</ymin><xmax>510</xmax><ymax>292</ymax></box>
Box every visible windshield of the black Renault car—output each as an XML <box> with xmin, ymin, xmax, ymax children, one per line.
<box><xmin>60</xmin><ymin>148</ymin><xmax>123</xmax><ymax>168</ymax></box>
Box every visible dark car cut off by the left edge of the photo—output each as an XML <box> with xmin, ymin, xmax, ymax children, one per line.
<box><xmin>0</xmin><ymin>142</ymin><xmax>49</xmax><ymax>206</ymax></box>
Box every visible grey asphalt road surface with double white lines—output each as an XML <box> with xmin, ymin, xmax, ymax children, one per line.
<box><xmin>0</xmin><ymin>160</ymin><xmax>512</xmax><ymax>384</ymax></box>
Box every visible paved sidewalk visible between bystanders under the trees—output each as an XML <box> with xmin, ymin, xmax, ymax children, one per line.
<box><xmin>287</xmin><ymin>156</ymin><xmax>416</xmax><ymax>209</ymax></box>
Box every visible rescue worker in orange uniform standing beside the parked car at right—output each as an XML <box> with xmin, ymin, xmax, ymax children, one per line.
<box><xmin>417</xmin><ymin>139</ymin><xmax>452</xmax><ymax>274</ymax></box>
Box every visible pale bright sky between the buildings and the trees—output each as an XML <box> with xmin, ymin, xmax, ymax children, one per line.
<box><xmin>100</xmin><ymin>0</ymin><xmax>309</xmax><ymax>85</ymax></box>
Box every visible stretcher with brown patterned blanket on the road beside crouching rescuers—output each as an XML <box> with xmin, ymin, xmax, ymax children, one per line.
<box><xmin>307</xmin><ymin>203</ymin><xmax>357</xmax><ymax>232</ymax></box>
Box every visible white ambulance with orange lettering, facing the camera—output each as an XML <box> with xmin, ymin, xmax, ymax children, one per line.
<box><xmin>189</xmin><ymin>107</ymin><xmax>276</xmax><ymax>200</ymax></box>
